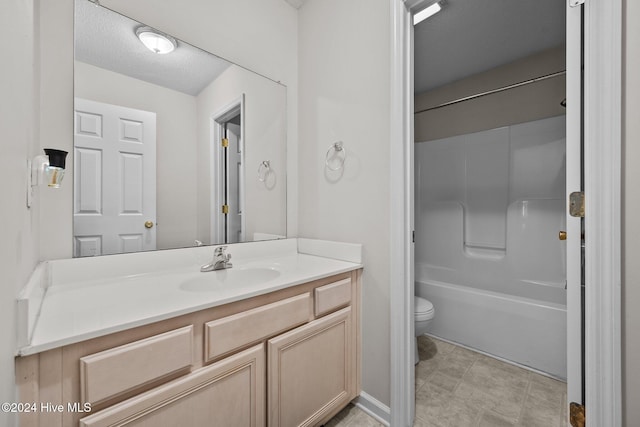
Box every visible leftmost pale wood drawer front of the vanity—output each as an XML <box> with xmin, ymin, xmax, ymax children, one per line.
<box><xmin>80</xmin><ymin>326</ymin><xmax>193</xmax><ymax>404</ymax></box>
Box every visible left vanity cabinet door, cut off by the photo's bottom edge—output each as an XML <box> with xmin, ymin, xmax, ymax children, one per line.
<box><xmin>80</xmin><ymin>344</ymin><xmax>266</xmax><ymax>427</ymax></box>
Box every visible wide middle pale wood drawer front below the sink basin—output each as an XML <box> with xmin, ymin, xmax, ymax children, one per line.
<box><xmin>204</xmin><ymin>292</ymin><xmax>312</xmax><ymax>362</ymax></box>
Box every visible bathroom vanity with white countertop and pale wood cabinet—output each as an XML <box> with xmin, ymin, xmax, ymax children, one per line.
<box><xmin>16</xmin><ymin>239</ymin><xmax>362</xmax><ymax>427</ymax></box>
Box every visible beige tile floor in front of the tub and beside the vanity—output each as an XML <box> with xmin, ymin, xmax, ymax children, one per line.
<box><xmin>326</xmin><ymin>336</ymin><xmax>567</xmax><ymax>427</ymax></box>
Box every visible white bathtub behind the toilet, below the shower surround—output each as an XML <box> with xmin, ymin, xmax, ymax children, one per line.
<box><xmin>416</xmin><ymin>278</ymin><xmax>567</xmax><ymax>379</ymax></box>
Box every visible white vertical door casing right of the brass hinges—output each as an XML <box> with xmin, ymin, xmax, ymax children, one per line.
<box><xmin>583</xmin><ymin>0</ymin><xmax>622</xmax><ymax>427</ymax></box>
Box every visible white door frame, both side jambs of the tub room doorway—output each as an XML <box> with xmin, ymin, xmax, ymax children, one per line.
<box><xmin>390</xmin><ymin>0</ymin><xmax>622</xmax><ymax>427</ymax></box>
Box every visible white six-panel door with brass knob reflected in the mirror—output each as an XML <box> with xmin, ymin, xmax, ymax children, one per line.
<box><xmin>73</xmin><ymin>98</ymin><xmax>156</xmax><ymax>257</ymax></box>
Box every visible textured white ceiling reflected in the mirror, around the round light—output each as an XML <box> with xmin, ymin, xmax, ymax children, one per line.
<box><xmin>75</xmin><ymin>0</ymin><xmax>231</xmax><ymax>96</ymax></box>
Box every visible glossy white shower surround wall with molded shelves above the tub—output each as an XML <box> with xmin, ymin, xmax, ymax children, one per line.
<box><xmin>415</xmin><ymin>116</ymin><xmax>566</xmax><ymax>304</ymax></box>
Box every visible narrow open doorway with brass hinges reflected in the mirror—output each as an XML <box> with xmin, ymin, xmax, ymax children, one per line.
<box><xmin>212</xmin><ymin>100</ymin><xmax>244</xmax><ymax>243</ymax></box>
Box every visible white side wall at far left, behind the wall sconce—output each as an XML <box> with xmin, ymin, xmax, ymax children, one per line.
<box><xmin>0</xmin><ymin>0</ymin><xmax>40</xmax><ymax>427</ymax></box>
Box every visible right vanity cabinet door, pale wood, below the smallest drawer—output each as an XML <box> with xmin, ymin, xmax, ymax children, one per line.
<box><xmin>267</xmin><ymin>307</ymin><xmax>357</xmax><ymax>427</ymax></box>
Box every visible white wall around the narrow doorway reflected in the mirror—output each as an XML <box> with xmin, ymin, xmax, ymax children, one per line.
<box><xmin>197</xmin><ymin>65</ymin><xmax>287</xmax><ymax>242</ymax></box>
